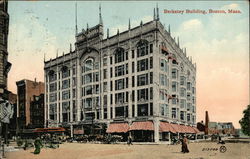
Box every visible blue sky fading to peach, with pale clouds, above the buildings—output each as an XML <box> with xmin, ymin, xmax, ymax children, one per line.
<box><xmin>8</xmin><ymin>1</ymin><xmax>249</xmax><ymax>128</ymax></box>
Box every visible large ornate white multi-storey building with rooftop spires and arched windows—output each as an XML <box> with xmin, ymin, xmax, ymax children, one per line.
<box><xmin>44</xmin><ymin>8</ymin><xmax>196</xmax><ymax>142</ymax></box>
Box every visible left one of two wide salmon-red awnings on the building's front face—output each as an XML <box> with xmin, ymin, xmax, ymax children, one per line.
<box><xmin>106</xmin><ymin>123</ymin><xmax>129</xmax><ymax>133</ymax></box>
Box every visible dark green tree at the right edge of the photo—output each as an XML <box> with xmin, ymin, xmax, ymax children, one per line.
<box><xmin>239</xmin><ymin>105</ymin><xmax>250</xmax><ymax>136</ymax></box>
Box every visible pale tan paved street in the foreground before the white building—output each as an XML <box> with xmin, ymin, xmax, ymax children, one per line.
<box><xmin>6</xmin><ymin>143</ymin><xmax>250</xmax><ymax>159</ymax></box>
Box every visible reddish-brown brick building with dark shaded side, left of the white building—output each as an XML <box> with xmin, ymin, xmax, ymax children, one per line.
<box><xmin>16</xmin><ymin>79</ymin><xmax>44</xmax><ymax>129</ymax></box>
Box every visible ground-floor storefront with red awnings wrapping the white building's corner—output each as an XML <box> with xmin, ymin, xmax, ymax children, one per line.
<box><xmin>106</xmin><ymin>120</ymin><xmax>199</xmax><ymax>143</ymax></box>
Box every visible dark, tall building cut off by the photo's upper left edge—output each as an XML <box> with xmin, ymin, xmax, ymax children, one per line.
<box><xmin>0</xmin><ymin>0</ymin><xmax>11</xmax><ymax>99</ymax></box>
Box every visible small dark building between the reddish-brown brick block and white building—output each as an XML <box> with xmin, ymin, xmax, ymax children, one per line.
<box><xmin>30</xmin><ymin>94</ymin><xmax>44</xmax><ymax>128</ymax></box>
